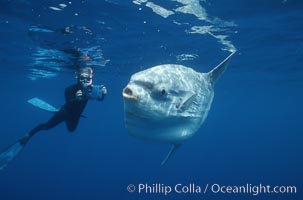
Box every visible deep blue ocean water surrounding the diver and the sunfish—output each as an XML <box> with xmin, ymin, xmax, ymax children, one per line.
<box><xmin>0</xmin><ymin>0</ymin><xmax>303</xmax><ymax>200</ymax></box>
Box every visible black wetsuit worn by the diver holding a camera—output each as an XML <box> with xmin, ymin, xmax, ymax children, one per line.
<box><xmin>28</xmin><ymin>84</ymin><xmax>88</xmax><ymax>137</ymax></box>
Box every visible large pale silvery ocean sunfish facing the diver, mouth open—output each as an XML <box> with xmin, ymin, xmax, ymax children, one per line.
<box><xmin>122</xmin><ymin>53</ymin><xmax>234</xmax><ymax>165</ymax></box>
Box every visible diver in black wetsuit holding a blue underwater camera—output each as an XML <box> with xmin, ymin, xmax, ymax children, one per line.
<box><xmin>0</xmin><ymin>67</ymin><xmax>107</xmax><ymax>170</ymax></box>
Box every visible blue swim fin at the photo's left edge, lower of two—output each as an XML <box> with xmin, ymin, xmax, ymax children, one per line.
<box><xmin>0</xmin><ymin>136</ymin><xmax>30</xmax><ymax>171</ymax></box>
